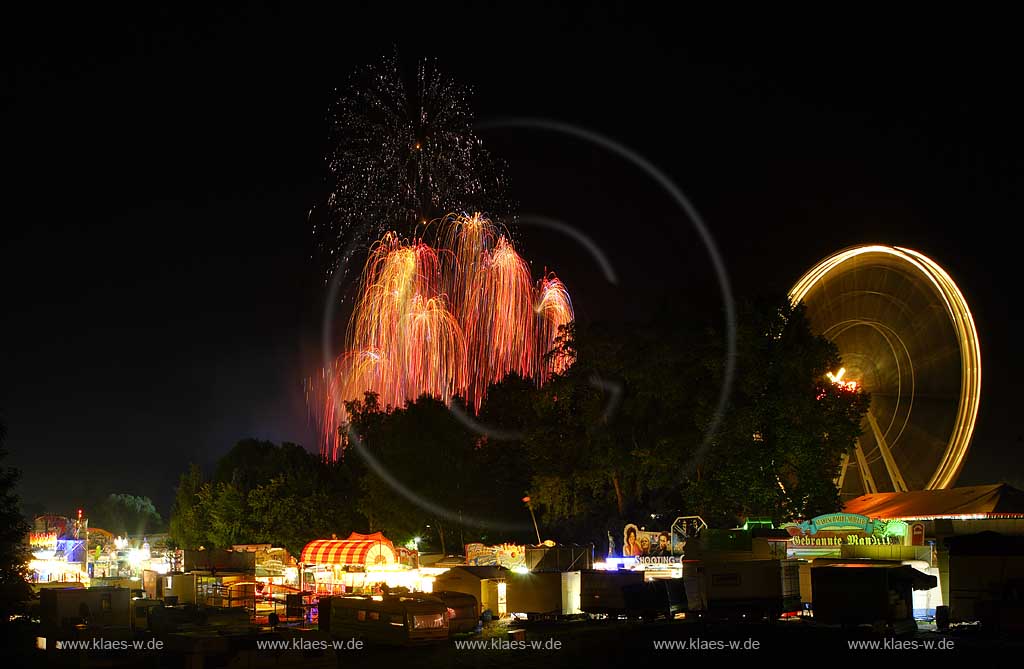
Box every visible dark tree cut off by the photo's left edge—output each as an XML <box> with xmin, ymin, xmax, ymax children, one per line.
<box><xmin>0</xmin><ymin>422</ymin><xmax>32</xmax><ymax>623</ymax></box>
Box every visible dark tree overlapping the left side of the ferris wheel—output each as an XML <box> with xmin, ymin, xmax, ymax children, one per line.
<box><xmin>686</xmin><ymin>298</ymin><xmax>869</xmax><ymax>525</ymax></box>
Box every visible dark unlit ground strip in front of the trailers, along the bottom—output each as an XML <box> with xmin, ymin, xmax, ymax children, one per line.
<box><xmin>16</xmin><ymin>620</ymin><xmax>1024</xmax><ymax>669</ymax></box>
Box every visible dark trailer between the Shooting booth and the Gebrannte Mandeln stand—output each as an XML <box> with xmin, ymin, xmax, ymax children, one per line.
<box><xmin>683</xmin><ymin>559</ymin><xmax>803</xmax><ymax>622</ymax></box>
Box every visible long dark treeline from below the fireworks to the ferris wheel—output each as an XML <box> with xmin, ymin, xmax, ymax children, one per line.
<box><xmin>171</xmin><ymin>298</ymin><xmax>868</xmax><ymax>552</ymax></box>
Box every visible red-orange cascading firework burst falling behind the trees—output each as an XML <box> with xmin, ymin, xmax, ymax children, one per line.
<box><xmin>307</xmin><ymin>214</ymin><xmax>573</xmax><ymax>460</ymax></box>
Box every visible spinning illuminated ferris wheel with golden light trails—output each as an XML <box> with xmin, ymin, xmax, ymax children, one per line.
<box><xmin>790</xmin><ymin>245</ymin><xmax>981</xmax><ymax>497</ymax></box>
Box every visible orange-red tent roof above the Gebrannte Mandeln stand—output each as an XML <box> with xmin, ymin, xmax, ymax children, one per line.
<box><xmin>843</xmin><ymin>484</ymin><xmax>1024</xmax><ymax>520</ymax></box>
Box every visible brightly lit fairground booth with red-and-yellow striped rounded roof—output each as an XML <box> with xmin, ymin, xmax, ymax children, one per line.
<box><xmin>299</xmin><ymin>532</ymin><xmax>425</xmax><ymax>595</ymax></box>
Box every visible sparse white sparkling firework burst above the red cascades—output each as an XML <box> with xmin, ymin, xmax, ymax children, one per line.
<box><xmin>313</xmin><ymin>55</ymin><xmax>509</xmax><ymax>278</ymax></box>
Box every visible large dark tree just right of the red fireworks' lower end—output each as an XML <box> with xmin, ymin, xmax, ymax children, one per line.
<box><xmin>525</xmin><ymin>313</ymin><xmax>714</xmax><ymax>538</ymax></box>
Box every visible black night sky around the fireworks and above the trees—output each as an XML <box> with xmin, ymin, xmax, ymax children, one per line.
<box><xmin>0</xmin><ymin>4</ymin><xmax>1024</xmax><ymax>515</ymax></box>
